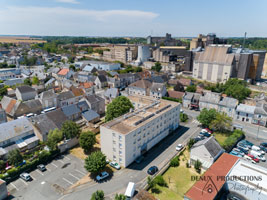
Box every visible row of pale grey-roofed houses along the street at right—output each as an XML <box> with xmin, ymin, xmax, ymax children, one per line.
<box><xmin>183</xmin><ymin>92</ymin><xmax>267</xmax><ymax>126</ymax></box>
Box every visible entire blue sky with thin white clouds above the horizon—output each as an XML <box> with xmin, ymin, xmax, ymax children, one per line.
<box><xmin>0</xmin><ymin>0</ymin><xmax>267</xmax><ymax>37</ymax></box>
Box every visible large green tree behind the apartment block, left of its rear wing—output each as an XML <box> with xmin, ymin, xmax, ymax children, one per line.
<box><xmin>105</xmin><ymin>96</ymin><xmax>134</xmax><ymax>121</ymax></box>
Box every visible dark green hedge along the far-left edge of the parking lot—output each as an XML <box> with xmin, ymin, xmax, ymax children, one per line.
<box><xmin>0</xmin><ymin>150</ymin><xmax>59</xmax><ymax>183</ymax></box>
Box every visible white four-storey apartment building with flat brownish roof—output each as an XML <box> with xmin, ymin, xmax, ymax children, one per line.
<box><xmin>100</xmin><ymin>96</ymin><xmax>181</xmax><ymax>167</ymax></box>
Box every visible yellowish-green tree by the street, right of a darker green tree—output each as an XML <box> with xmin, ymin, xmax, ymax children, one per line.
<box><xmin>209</xmin><ymin>113</ymin><xmax>232</xmax><ymax>132</ymax></box>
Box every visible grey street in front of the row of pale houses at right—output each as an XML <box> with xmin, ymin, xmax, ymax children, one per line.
<box><xmin>183</xmin><ymin>108</ymin><xmax>267</xmax><ymax>141</ymax></box>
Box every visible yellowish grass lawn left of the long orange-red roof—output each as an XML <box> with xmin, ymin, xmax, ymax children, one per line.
<box><xmin>150</xmin><ymin>150</ymin><xmax>199</xmax><ymax>200</ymax></box>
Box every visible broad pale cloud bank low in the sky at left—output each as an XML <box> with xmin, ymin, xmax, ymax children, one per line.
<box><xmin>0</xmin><ymin>6</ymin><xmax>159</xmax><ymax>36</ymax></box>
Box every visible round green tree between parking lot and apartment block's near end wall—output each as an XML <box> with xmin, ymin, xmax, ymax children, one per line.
<box><xmin>84</xmin><ymin>151</ymin><xmax>107</xmax><ymax>174</ymax></box>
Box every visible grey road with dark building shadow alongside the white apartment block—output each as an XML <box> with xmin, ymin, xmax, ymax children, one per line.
<box><xmin>59</xmin><ymin>121</ymin><xmax>200</xmax><ymax>200</ymax></box>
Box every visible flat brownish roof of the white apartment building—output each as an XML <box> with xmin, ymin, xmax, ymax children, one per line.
<box><xmin>102</xmin><ymin>96</ymin><xmax>179</xmax><ymax>134</ymax></box>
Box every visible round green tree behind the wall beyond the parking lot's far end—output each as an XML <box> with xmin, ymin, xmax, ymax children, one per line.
<box><xmin>61</xmin><ymin>120</ymin><xmax>81</xmax><ymax>139</ymax></box>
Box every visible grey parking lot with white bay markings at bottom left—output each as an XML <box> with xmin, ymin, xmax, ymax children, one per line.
<box><xmin>8</xmin><ymin>154</ymin><xmax>87</xmax><ymax>199</ymax></box>
